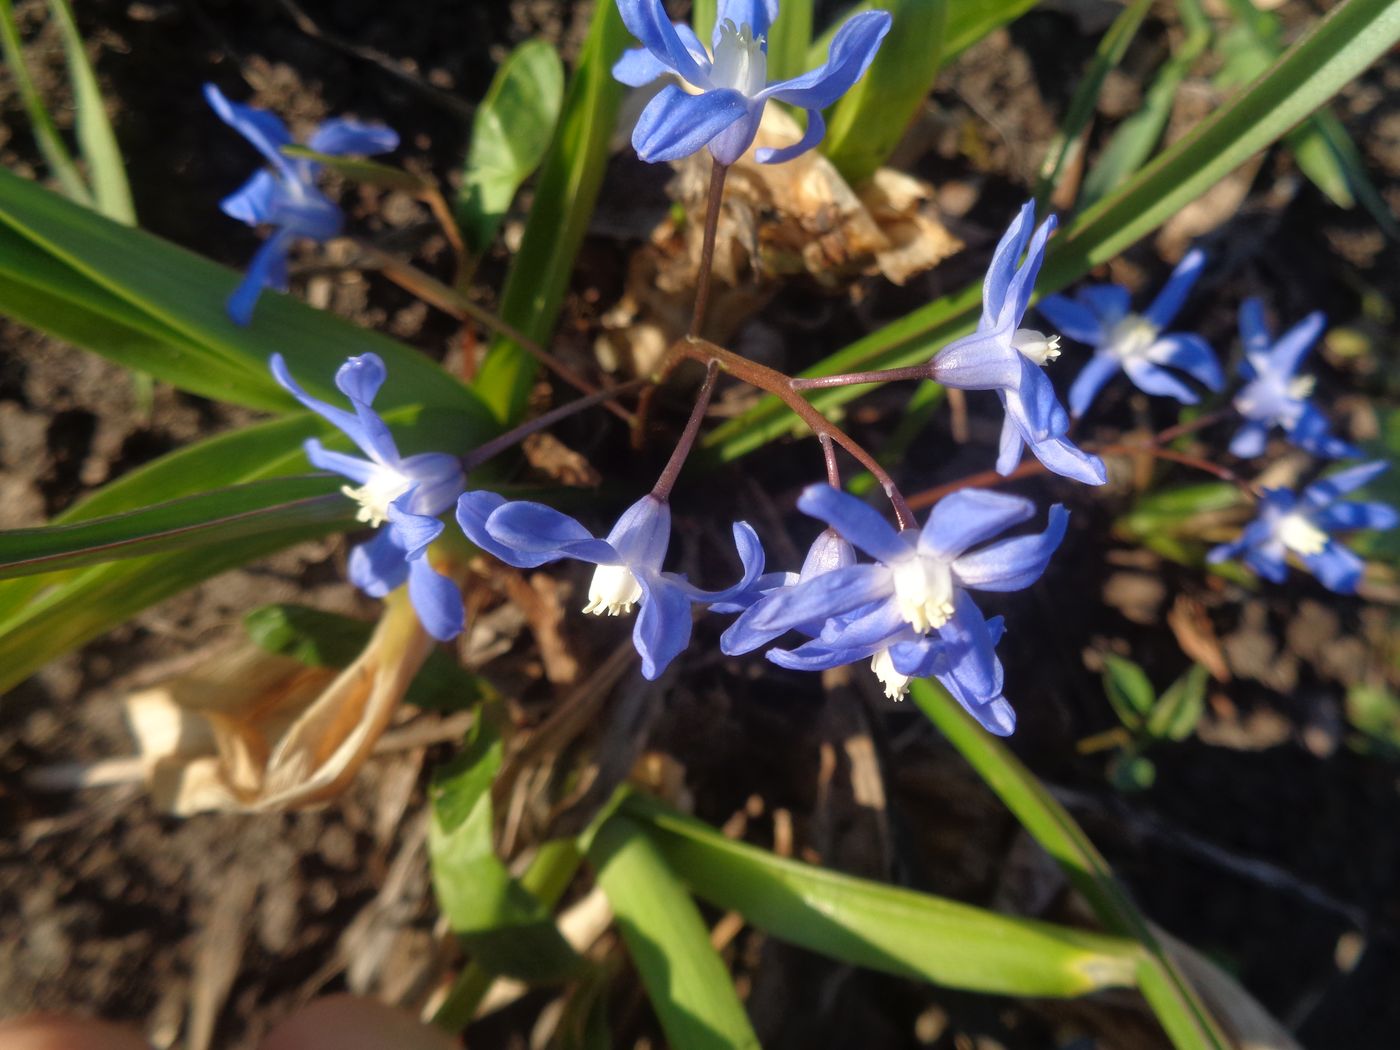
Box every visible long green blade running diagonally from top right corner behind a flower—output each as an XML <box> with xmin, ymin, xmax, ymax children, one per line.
<box><xmin>704</xmin><ymin>0</ymin><xmax>1400</xmax><ymax>461</ymax></box>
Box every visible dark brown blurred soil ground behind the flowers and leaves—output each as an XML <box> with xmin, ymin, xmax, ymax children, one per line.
<box><xmin>0</xmin><ymin>0</ymin><xmax>1400</xmax><ymax>1050</ymax></box>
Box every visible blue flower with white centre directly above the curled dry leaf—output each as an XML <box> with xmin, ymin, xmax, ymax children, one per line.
<box><xmin>270</xmin><ymin>354</ymin><xmax>466</xmax><ymax>641</ymax></box>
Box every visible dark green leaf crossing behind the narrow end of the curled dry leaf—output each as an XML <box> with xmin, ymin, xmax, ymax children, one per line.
<box><xmin>244</xmin><ymin>605</ymin><xmax>494</xmax><ymax>711</ymax></box>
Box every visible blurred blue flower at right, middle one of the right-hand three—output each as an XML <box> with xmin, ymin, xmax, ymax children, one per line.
<box><xmin>1229</xmin><ymin>300</ymin><xmax>1361</xmax><ymax>459</ymax></box>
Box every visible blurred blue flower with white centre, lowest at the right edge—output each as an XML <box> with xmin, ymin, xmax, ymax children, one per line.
<box><xmin>1207</xmin><ymin>461</ymin><xmax>1400</xmax><ymax>594</ymax></box>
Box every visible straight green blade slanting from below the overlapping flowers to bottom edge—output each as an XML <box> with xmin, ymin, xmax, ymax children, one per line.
<box><xmin>910</xmin><ymin>680</ymin><xmax>1231</xmax><ymax>1050</ymax></box>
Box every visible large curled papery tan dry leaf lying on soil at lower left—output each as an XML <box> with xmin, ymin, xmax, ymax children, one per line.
<box><xmin>126</xmin><ymin>589</ymin><xmax>433</xmax><ymax>816</ymax></box>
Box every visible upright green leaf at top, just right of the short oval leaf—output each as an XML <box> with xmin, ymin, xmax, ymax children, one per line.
<box><xmin>473</xmin><ymin>3</ymin><xmax>631</xmax><ymax>421</ymax></box>
